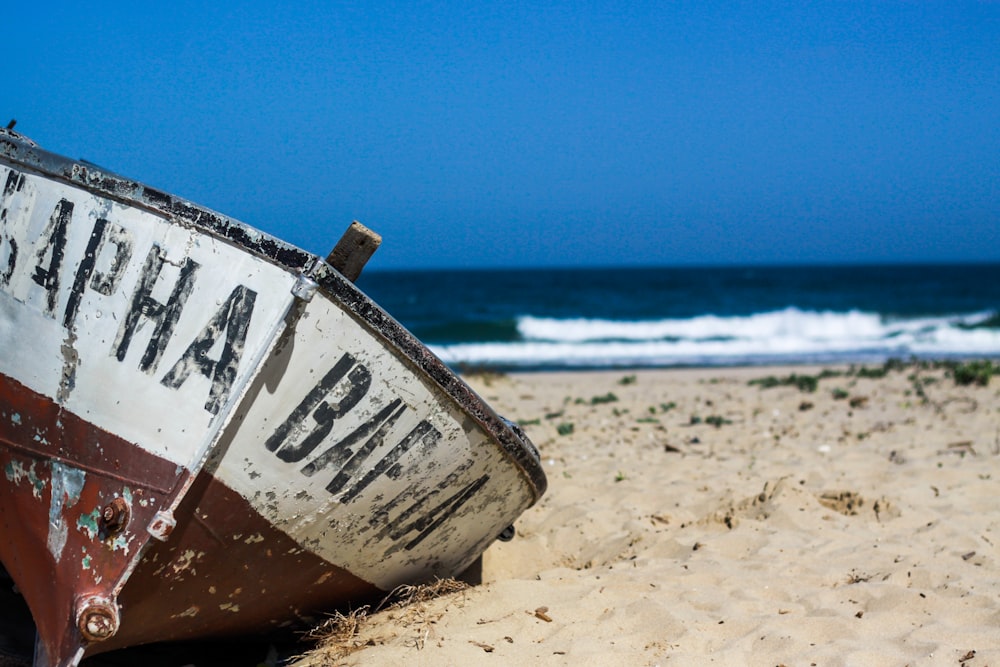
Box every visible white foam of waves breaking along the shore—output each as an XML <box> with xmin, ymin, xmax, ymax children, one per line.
<box><xmin>433</xmin><ymin>308</ymin><xmax>1000</xmax><ymax>367</ymax></box>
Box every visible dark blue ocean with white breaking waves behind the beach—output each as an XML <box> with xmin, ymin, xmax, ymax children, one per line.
<box><xmin>358</xmin><ymin>264</ymin><xmax>1000</xmax><ymax>370</ymax></box>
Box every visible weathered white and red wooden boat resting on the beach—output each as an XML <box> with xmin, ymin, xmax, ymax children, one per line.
<box><xmin>0</xmin><ymin>129</ymin><xmax>546</xmax><ymax>667</ymax></box>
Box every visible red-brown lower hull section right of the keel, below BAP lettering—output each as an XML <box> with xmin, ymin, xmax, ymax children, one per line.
<box><xmin>105</xmin><ymin>473</ymin><xmax>384</xmax><ymax>651</ymax></box>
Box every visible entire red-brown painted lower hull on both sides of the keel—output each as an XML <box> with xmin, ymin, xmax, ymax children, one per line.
<box><xmin>0</xmin><ymin>376</ymin><xmax>384</xmax><ymax>655</ymax></box>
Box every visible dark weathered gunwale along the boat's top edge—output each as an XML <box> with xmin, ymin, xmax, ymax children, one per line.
<box><xmin>0</xmin><ymin>127</ymin><xmax>547</xmax><ymax>504</ymax></box>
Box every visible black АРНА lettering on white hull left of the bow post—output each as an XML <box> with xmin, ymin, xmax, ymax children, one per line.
<box><xmin>0</xmin><ymin>169</ymin><xmax>257</xmax><ymax>415</ymax></box>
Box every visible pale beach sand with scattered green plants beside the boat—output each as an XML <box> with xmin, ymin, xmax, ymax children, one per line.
<box><xmin>286</xmin><ymin>367</ymin><xmax>1000</xmax><ymax>667</ymax></box>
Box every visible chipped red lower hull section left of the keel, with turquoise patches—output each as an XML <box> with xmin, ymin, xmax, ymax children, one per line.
<box><xmin>0</xmin><ymin>376</ymin><xmax>184</xmax><ymax>655</ymax></box>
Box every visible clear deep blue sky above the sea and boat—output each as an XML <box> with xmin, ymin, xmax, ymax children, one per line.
<box><xmin>0</xmin><ymin>0</ymin><xmax>1000</xmax><ymax>268</ymax></box>
